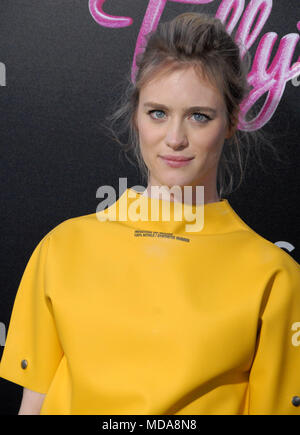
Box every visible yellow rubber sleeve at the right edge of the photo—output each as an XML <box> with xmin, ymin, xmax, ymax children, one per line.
<box><xmin>248</xmin><ymin>251</ymin><xmax>300</xmax><ymax>415</ymax></box>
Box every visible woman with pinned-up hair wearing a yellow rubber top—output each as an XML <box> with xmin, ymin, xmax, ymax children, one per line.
<box><xmin>0</xmin><ymin>13</ymin><xmax>300</xmax><ymax>415</ymax></box>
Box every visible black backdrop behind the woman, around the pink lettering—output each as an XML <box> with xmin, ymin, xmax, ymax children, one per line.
<box><xmin>0</xmin><ymin>0</ymin><xmax>300</xmax><ymax>414</ymax></box>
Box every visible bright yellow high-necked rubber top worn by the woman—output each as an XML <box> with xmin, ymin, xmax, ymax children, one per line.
<box><xmin>0</xmin><ymin>189</ymin><xmax>300</xmax><ymax>415</ymax></box>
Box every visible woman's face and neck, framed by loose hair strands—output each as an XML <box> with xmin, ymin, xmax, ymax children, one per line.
<box><xmin>135</xmin><ymin>67</ymin><xmax>236</xmax><ymax>202</ymax></box>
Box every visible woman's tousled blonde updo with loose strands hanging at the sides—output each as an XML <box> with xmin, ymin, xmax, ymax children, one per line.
<box><xmin>102</xmin><ymin>12</ymin><xmax>283</xmax><ymax>199</ymax></box>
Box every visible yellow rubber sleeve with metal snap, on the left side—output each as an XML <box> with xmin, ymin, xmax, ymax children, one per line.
<box><xmin>0</xmin><ymin>235</ymin><xmax>63</xmax><ymax>394</ymax></box>
